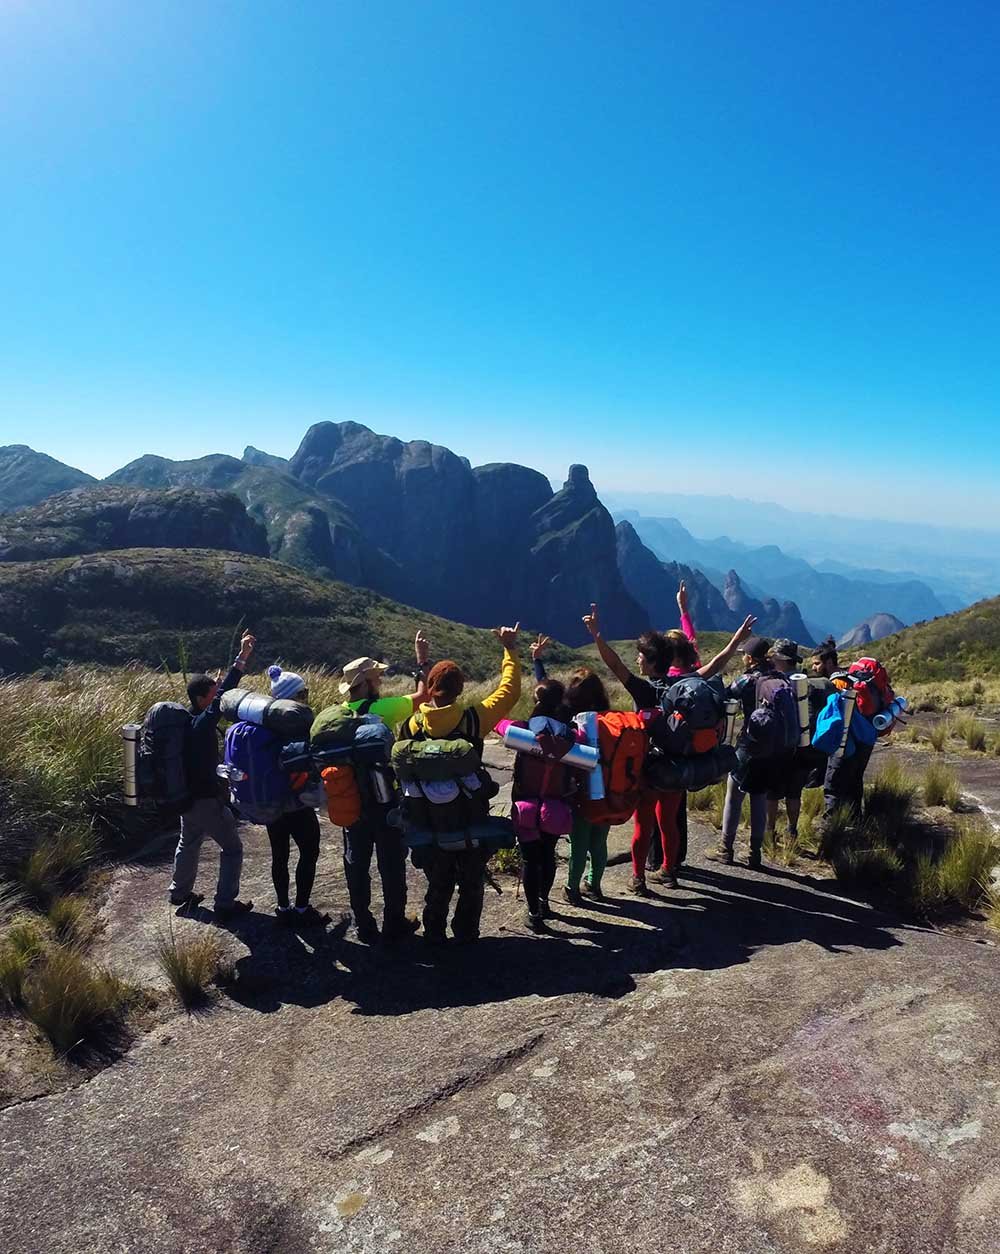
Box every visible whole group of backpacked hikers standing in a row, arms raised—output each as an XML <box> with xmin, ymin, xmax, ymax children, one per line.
<box><xmin>158</xmin><ymin>583</ymin><xmax>888</xmax><ymax>944</ymax></box>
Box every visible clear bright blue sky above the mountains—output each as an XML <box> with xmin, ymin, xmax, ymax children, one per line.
<box><xmin>0</xmin><ymin>0</ymin><xmax>1000</xmax><ymax>527</ymax></box>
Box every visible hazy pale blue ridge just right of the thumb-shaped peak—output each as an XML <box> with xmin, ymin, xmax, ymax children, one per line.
<box><xmin>619</xmin><ymin>512</ymin><xmax>947</xmax><ymax>636</ymax></box>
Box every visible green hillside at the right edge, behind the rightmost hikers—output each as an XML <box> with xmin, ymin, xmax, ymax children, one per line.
<box><xmin>856</xmin><ymin>597</ymin><xmax>1000</xmax><ymax>683</ymax></box>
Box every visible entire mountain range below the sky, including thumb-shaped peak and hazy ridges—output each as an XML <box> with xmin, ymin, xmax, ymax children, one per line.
<box><xmin>0</xmin><ymin>423</ymin><xmax>968</xmax><ymax>662</ymax></box>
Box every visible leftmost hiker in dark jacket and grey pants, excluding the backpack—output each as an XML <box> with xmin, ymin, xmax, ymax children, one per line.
<box><xmin>169</xmin><ymin>632</ymin><xmax>256</xmax><ymax>919</ymax></box>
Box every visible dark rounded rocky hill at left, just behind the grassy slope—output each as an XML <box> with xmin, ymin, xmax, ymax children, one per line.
<box><xmin>0</xmin><ymin>484</ymin><xmax>267</xmax><ymax>562</ymax></box>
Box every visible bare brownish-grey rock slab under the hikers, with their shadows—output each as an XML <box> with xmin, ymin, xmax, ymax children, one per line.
<box><xmin>0</xmin><ymin>737</ymin><xmax>1000</xmax><ymax>1254</ymax></box>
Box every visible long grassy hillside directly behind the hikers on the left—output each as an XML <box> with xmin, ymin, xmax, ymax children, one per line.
<box><xmin>0</xmin><ymin>549</ymin><xmax>580</xmax><ymax>678</ymax></box>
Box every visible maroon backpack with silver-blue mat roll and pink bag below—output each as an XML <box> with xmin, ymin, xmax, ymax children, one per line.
<box><xmin>504</xmin><ymin>716</ymin><xmax>590</xmax><ymax>844</ymax></box>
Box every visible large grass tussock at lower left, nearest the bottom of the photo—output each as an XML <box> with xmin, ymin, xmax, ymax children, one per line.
<box><xmin>23</xmin><ymin>946</ymin><xmax>134</xmax><ymax>1055</ymax></box>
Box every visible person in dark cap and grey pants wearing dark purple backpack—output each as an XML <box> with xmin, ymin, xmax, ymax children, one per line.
<box><xmin>708</xmin><ymin>636</ymin><xmax>799</xmax><ymax>870</ymax></box>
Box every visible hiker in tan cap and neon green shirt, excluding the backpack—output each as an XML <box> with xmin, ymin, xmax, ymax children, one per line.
<box><xmin>317</xmin><ymin>631</ymin><xmax>430</xmax><ymax>944</ymax></box>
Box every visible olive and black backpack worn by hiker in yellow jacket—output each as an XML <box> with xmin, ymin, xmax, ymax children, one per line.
<box><xmin>393</xmin><ymin>707</ymin><xmax>512</xmax><ymax>849</ymax></box>
